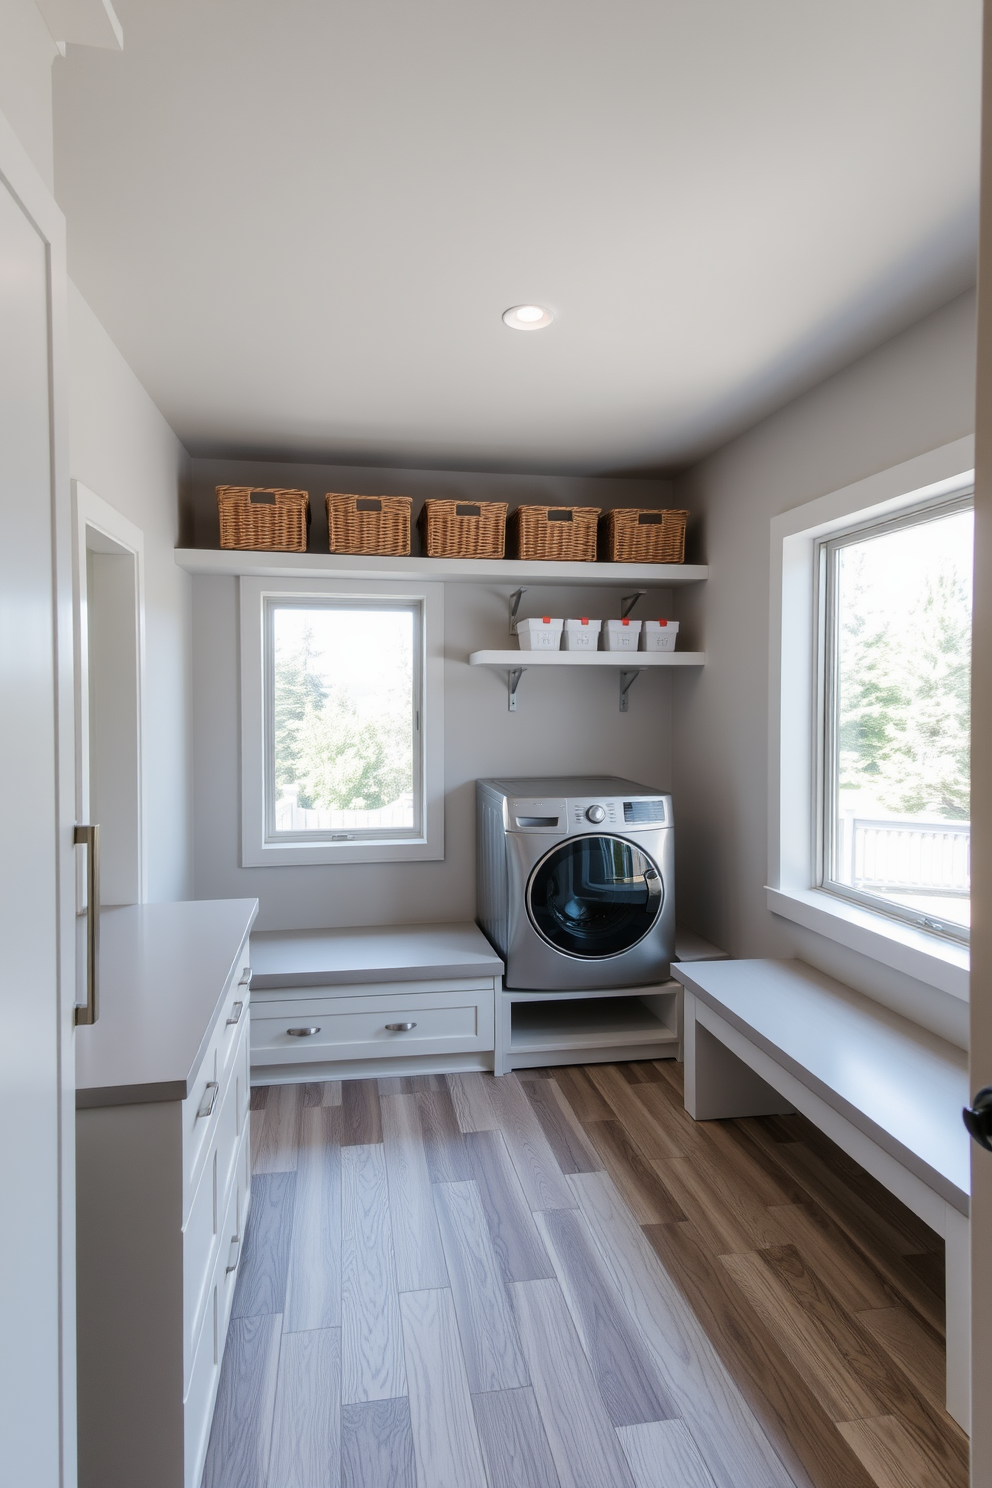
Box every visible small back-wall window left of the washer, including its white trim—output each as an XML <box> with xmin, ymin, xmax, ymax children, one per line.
<box><xmin>241</xmin><ymin>579</ymin><xmax>443</xmax><ymax>865</ymax></box>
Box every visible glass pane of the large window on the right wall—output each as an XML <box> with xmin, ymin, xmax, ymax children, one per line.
<box><xmin>827</xmin><ymin>510</ymin><xmax>974</xmax><ymax>927</ymax></box>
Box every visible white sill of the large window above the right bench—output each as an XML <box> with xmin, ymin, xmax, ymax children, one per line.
<box><xmin>766</xmin><ymin>888</ymin><xmax>971</xmax><ymax>1001</ymax></box>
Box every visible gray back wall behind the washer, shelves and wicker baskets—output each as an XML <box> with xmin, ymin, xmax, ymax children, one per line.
<box><xmin>190</xmin><ymin>460</ymin><xmax>674</xmax><ymax>930</ymax></box>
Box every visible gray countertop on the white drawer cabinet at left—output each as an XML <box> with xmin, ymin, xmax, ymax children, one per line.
<box><xmin>76</xmin><ymin>899</ymin><xmax>259</xmax><ymax>1107</ymax></box>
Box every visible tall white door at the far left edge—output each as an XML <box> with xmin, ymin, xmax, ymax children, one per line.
<box><xmin>0</xmin><ymin>116</ymin><xmax>74</xmax><ymax>1488</ymax></box>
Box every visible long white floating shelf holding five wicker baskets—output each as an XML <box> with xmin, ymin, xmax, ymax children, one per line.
<box><xmin>175</xmin><ymin>548</ymin><xmax>709</xmax><ymax>589</ymax></box>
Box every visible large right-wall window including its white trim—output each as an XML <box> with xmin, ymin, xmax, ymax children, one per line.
<box><xmin>766</xmin><ymin>437</ymin><xmax>974</xmax><ymax>999</ymax></box>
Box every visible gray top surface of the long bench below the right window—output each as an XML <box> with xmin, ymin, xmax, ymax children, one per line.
<box><xmin>672</xmin><ymin>961</ymin><xmax>971</xmax><ymax>1213</ymax></box>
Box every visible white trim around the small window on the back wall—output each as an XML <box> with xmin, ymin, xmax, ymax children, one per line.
<box><xmin>239</xmin><ymin>576</ymin><xmax>445</xmax><ymax>868</ymax></box>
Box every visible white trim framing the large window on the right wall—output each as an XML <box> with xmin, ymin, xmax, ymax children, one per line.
<box><xmin>767</xmin><ymin>436</ymin><xmax>974</xmax><ymax>1000</ymax></box>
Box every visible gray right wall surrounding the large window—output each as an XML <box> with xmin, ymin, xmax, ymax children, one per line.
<box><xmin>672</xmin><ymin>284</ymin><xmax>976</xmax><ymax>1045</ymax></box>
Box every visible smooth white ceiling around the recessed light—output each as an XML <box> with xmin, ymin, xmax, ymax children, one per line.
<box><xmin>55</xmin><ymin>0</ymin><xmax>982</xmax><ymax>472</ymax></box>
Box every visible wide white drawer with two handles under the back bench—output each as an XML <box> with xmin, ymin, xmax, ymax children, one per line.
<box><xmin>251</xmin><ymin>984</ymin><xmax>494</xmax><ymax>1064</ymax></box>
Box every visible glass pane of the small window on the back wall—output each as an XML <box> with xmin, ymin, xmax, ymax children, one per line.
<box><xmin>269</xmin><ymin>604</ymin><xmax>419</xmax><ymax>835</ymax></box>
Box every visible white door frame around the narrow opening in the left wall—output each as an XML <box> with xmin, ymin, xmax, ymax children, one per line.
<box><xmin>71</xmin><ymin>481</ymin><xmax>147</xmax><ymax>911</ymax></box>
